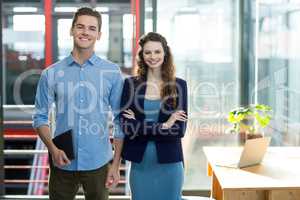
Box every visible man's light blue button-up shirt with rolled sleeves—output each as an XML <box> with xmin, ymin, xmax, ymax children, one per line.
<box><xmin>33</xmin><ymin>54</ymin><xmax>124</xmax><ymax>171</ymax></box>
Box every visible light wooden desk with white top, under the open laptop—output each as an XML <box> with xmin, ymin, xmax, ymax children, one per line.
<box><xmin>203</xmin><ymin>147</ymin><xmax>300</xmax><ymax>200</ymax></box>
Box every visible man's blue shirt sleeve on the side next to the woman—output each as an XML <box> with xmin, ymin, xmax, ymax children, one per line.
<box><xmin>109</xmin><ymin>67</ymin><xmax>125</xmax><ymax>139</ymax></box>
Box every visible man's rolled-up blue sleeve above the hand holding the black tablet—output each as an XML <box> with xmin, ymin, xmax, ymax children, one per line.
<box><xmin>32</xmin><ymin>70</ymin><xmax>54</xmax><ymax>128</ymax></box>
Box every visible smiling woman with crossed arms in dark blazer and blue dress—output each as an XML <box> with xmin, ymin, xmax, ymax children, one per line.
<box><xmin>120</xmin><ymin>32</ymin><xmax>187</xmax><ymax>200</ymax></box>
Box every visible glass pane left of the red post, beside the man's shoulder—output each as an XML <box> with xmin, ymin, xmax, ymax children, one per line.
<box><xmin>2</xmin><ymin>11</ymin><xmax>45</xmax><ymax>105</ymax></box>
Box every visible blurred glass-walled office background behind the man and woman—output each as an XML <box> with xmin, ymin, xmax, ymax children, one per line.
<box><xmin>0</xmin><ymin>0</ymin><xmax>300</xmax><ymax>196</ymax></box>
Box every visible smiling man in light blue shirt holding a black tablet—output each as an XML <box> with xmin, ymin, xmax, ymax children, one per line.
<box><xmin>33</xmin><ymin>7</ymin><xmax>123</xmax><ymax>200</ymax></box>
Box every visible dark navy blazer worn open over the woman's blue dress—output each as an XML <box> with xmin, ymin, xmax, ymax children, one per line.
<box><xmin>119</xmin><ymin>77</ymin><xmax>187</xmax><ymax>163</ymax></box>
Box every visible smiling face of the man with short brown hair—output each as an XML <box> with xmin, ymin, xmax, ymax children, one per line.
<box><xmin>71</xmin><ymin>15</ymin><xmax>101</xmax><ymax>51</ymax></box>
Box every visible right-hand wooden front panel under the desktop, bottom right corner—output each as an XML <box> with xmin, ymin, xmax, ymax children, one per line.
<box><xmin>267</xmin><ymin>190</ymin><xmax>300</xmax><ymax>200</ymax></box>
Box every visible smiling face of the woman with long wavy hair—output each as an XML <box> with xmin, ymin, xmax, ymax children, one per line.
<box><xmin>143</xmin><ymin>41</ymin><xmax>165</xmax><ymax>69</ymax></box>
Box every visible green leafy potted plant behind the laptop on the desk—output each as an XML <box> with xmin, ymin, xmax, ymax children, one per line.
<box><xmin>228</xmin><ymin>104</ymin><xmax>272</xmax><ymax>141</ymax></box>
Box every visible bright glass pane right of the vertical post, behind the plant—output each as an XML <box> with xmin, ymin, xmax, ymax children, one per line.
<box><xmin>252</xmin><ymin>0</ymin><xmax>300</xmax><ymax>145</ymax></box>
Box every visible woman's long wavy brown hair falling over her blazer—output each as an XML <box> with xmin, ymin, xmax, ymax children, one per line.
<box><xmin>136</xmin><ymin>32</ymin><xmax>177</xmax><ymax>108</ymax></box>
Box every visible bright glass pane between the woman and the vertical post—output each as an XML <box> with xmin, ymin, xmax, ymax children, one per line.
<box><xmin>157</xmin><ymin>0</ymin><xmax>239</xmax><ymax>190</ymax></box>
